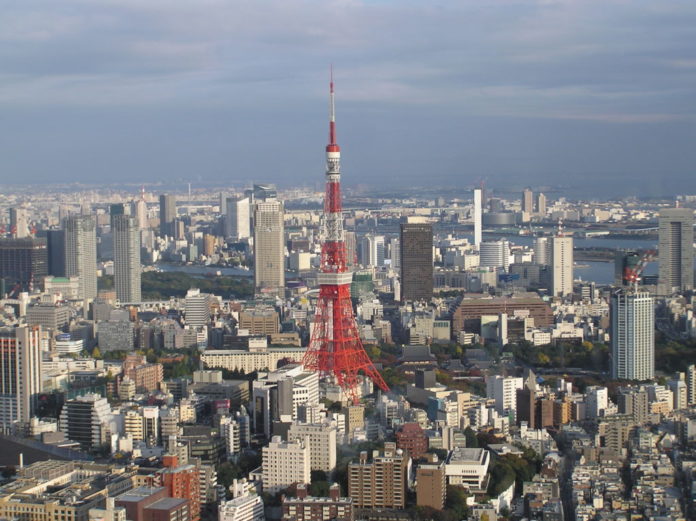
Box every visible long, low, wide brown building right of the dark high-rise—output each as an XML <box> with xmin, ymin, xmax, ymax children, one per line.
<box><xmin>452</xmin><ymin>298</ymin><xmax>554</xmax><ymax>333</ymax></box>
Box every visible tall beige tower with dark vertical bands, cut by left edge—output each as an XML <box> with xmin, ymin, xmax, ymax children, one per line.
<box><xmin>0</xmin><ymin>326</ymin><xmax>42</xmax><ymax>432</ymax></box>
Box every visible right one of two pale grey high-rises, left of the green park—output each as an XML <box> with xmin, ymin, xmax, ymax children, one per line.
<box><xmin>111</xmin><ymin>204</ymin><xmax>141</xmax><ymax>302</ymax></box>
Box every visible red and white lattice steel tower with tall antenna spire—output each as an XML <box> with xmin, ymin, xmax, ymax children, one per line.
<box><xmin>302</xmin><ymin>74</ymin><xmax>389</xmax><ymax>403</ymax></box>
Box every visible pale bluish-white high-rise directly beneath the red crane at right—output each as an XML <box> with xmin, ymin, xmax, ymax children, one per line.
<box><xmin>609</xmin><ymin>290</ymin><xmax>655</xmax><ymax>380</ymax></box>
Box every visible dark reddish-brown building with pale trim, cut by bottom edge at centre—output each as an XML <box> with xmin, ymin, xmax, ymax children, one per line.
<box><xmin>282</xmin><ymin>483</ymin><xmax>355</xmax><ymax>521</ymax></box>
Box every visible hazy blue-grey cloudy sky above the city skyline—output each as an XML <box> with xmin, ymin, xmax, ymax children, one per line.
<box><xmin>0</xmin><ymin>0</ymin><xmax>696</xmax><ymax>195</ymax></box>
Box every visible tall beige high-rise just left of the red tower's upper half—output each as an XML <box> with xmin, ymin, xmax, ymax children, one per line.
<box><xmin>254</xmin><ymin>199</ymin><xmax>285</xmax><ymax>291</ymax></box>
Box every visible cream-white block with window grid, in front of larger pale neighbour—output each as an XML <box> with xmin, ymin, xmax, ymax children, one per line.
<box><xmin>262</xmin><ymin>436</ymin><xmax>311</xmax><ymax>494</ymax></box>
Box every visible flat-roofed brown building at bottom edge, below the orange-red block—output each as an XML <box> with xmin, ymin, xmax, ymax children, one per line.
<box><xmin>115</xmin><ymin>487</ymin><xmax>191</xmax><ymax>521</ymax></box>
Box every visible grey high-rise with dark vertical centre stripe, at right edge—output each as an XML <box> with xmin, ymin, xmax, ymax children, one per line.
<box><xmin>658</xmin><ymin>208</ymin><xmax>694</xmax><ymax>295</ymax></box>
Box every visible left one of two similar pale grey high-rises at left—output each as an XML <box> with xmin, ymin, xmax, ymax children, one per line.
<box><xmin>63</xmin><ymin>215</ymin><xmax>97</xmax><ymax>299</ymax></box>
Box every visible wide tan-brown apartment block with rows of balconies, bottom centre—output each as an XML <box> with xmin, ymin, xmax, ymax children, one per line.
<box><xmin>348</xmin><ymin>443</ymin><xmax>409</xmax><ymax>509</ymax></box>
